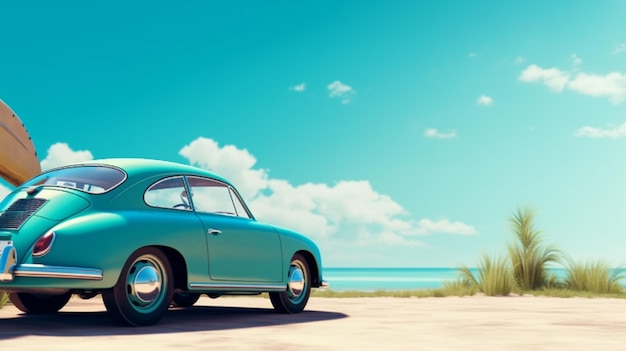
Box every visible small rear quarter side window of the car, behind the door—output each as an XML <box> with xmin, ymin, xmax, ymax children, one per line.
<box><xmin>143</xmin><ymin>177</ymin><xmax>191</xmax><ymax>211</ymax></box>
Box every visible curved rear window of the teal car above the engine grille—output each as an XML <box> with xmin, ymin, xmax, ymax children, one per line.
<box><xmin>23</xmin><ymin>165</ymin><xmax>126</xmax><ymax>194</ymax></box>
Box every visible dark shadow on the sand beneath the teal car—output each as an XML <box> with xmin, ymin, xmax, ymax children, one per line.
<box><xmin>0</xmin><ymin>306</ymin><xmax>347</xmax><ymax>340</ymax></box>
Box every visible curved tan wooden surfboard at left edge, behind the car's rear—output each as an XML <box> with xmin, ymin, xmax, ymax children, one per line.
<box><xmin>0</xmin><ymin>100</ymin><xmax>41</xmax><ymax>186</ymax></box>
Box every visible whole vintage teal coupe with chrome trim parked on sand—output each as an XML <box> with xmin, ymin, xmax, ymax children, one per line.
<box><xmin>0</xmin><ymin>159</ymin><xmax>326</xmax><ymax>326</ymax></box>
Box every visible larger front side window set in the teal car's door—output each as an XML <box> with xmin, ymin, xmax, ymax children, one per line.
<box><xmin>187</xmin><ymin>177</ymin><xmax>250</xmax><ymax>218</ymax></box>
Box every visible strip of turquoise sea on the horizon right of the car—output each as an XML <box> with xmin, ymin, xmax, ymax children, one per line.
<box><xmin>322</xmin><ymin>268</ymin><xmax>565</xmax><ymax>291</ymax></box>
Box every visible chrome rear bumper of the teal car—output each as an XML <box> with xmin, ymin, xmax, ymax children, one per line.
<box><xmin>0</xmin><ymin>245</ymin><xmax>102</xmax><ymax>282</ymax></box>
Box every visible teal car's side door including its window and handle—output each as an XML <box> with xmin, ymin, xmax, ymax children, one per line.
<box><xmin>187</xmin><ymin>177</ymin><xmax>283</xmax><ymax>283</ymax></box>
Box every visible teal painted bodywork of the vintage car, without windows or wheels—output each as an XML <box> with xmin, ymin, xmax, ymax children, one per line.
<box><xmin>0</xmin><ymin>159</ymin><xmax>322</xmax><ymax>292</ymax></box>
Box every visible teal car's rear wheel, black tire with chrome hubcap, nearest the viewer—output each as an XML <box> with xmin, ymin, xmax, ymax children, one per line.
<box><xmin>102</xmin><ymin>247</ymin><xmax>174</xmax><ymax>326</ymax></box>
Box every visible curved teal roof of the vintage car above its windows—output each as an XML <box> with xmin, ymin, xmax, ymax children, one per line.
<box><xmin>71</xmin><ymin>158</ymin><xmax>232</xmax><ymax>186</ymax></box>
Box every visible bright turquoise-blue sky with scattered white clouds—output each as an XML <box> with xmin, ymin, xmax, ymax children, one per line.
<box><xmin>0</xmin><ymin>1</ymin><xmax>626</xmax><ymax>267</ymax></box>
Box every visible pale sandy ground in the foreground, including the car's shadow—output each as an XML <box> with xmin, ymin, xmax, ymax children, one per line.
<box><xmin>0</xmin><ymin>296</ymin><xmax>626</xmax><ymax>351</ymax></box>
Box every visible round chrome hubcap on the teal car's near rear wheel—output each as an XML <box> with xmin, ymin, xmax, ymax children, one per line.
<box><xmin>126</xmin><ymin>255</ymin><xmax>164</xmax><ymax>309</ymax></box>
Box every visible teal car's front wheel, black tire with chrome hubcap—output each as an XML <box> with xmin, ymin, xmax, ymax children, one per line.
<box><xmin>269</xmin><ymin>254</ymin><xmax>311</xmax><ymax>313</ymax></box>
